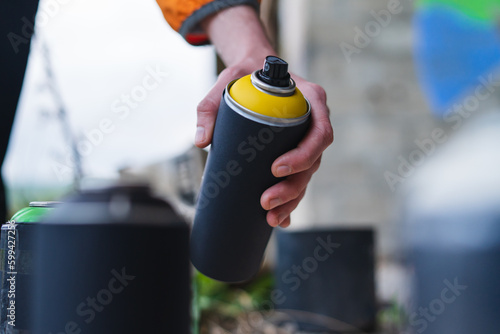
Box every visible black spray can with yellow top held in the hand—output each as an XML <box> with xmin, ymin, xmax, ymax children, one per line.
<box><xmin>190</xmin><ymin>56</ymin><xmax>310</xmax><ymax>282</ymax></box>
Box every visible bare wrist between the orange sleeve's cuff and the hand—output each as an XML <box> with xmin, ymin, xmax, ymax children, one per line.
<box><xmin>201</xmin><ymin>6</ymin><xmax>276</xmax><ymax>67</ymax></box>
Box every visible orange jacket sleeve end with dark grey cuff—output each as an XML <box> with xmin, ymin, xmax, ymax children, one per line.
<box><xmin>156</xmin><ymin>0</ymin><xmax>260</xmax><ymax>45</ymax></box>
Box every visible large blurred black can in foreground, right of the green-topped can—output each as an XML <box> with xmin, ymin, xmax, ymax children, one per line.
<box><xmin>33</xmin><ymin>186</ymin><xmax>191</xmax><ymax>334</ymax></box>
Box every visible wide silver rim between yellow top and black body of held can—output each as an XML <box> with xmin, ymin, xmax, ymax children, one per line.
<box><xmin>223</xmin><ymin>80</ymin><xmax>311</xmax><ymax>127</ymax></box>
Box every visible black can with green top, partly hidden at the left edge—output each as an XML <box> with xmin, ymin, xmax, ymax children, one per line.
<box><xmin>0</xmin><ymin>202</ymin><xmax>59</xmax><ymax>334</ymax></box>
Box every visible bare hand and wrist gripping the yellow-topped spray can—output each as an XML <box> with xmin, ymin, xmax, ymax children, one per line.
<box><xmin>195</xmin><ymin>6</ymin><xmax>333</xmax><ymax>228</ymax></box>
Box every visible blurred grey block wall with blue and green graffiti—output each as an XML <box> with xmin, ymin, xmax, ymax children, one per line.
<box><xmin>279</xmin><ymin>0</ymin><xmax>499</xmax><ymax>259</ymax></box>
